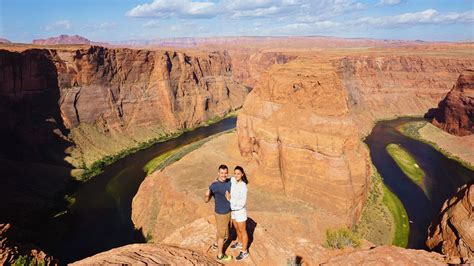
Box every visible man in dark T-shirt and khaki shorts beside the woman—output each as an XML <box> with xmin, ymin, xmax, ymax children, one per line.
<box><xmin>204</xmin><ymin>164</ymin><xmax>232</xmax><ymax>262</ymax></box>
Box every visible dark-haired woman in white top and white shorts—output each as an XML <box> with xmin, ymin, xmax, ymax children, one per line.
<box><xmin>226</xmin><ymin>166</ymin><xmax>249</xmax><ymax>261</ymax></box>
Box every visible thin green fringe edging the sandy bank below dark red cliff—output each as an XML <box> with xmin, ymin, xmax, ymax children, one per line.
<box><xmin>398</xmin><ymin>121</ymin><xmax>474</xmax><ymax>171</ymax></box>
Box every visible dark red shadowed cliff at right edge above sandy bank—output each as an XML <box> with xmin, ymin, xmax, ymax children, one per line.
<box><xmin>431</xmin><ymin>70</ymin><xmax>474</xmax><ymax>136</ymax></box>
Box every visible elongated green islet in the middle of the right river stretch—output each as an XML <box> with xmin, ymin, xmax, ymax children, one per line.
<box><xmin>385</xmin><ymin>143</ymin><xmax>425</xmax><ymax>188</ymax></box>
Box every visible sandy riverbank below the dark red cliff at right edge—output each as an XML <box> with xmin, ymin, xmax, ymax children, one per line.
<box><xmin>397</xmin><ymin>121</ymin><xmax>474</xmax><ymax>170</ymax></box>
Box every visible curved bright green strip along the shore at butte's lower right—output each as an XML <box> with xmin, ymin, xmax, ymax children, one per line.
<box><xmin>382</xmin><ymin>186</ymin><xmax>410</xmax><ymax>247</ymax></box>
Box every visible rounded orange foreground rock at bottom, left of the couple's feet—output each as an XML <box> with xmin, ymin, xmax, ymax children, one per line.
<box><xmin>70</xmin><ymin>244</ymin><xmax>220</xmax><ymax>265</ymax></box>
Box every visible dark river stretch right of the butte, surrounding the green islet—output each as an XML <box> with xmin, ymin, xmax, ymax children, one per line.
<box><xmin>365</xmin><ymin>118</ymin><xmax>474</xmax><ymax>249</ymax></box>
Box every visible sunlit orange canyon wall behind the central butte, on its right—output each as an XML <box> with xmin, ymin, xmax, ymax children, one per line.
<box><xmin>334</xmin><ymin>56</ymin><xmax>474</xmax><ymax>134</ymax></box>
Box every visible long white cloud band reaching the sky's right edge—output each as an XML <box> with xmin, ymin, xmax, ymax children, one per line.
<box><xmin>352</xmin><ymin>9</ymin><xmax>474</xmax><ymax>27</ymax></box>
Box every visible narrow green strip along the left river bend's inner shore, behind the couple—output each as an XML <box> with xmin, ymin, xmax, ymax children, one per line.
<box><xmin>143</xmin><ymin>129</ymin><xmax>233</xmax><ymax>175</ymax></box>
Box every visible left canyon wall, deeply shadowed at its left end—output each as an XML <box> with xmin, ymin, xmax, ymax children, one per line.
<box><xmin>0</xmin><ymin>45</ymin><xmax>248</xmax><ymax>262</ymax></box>
